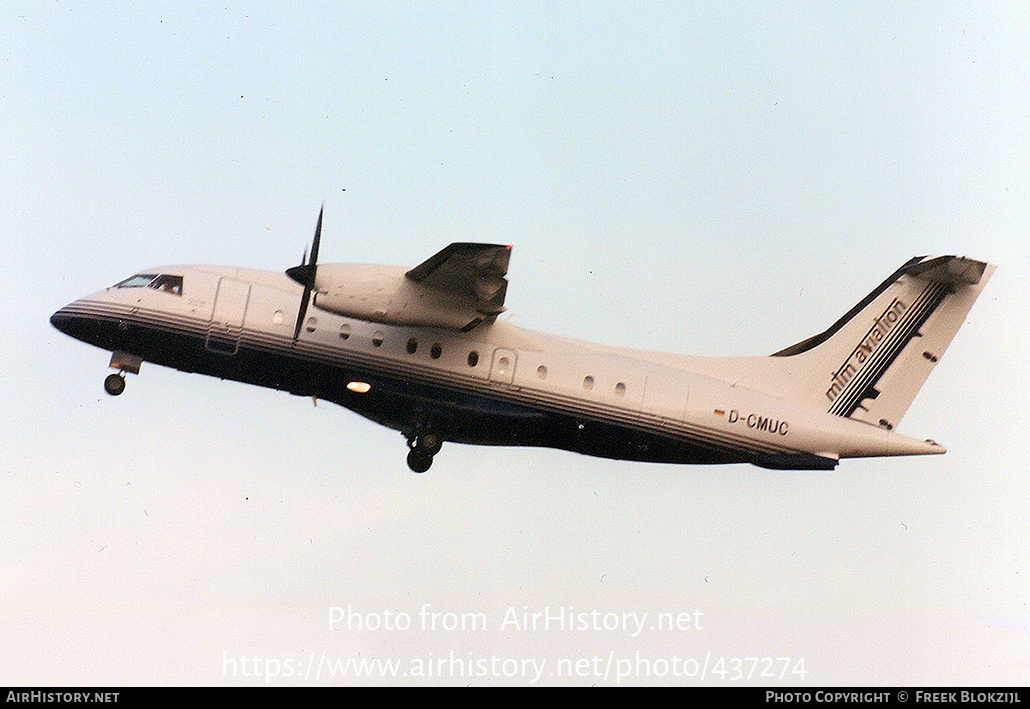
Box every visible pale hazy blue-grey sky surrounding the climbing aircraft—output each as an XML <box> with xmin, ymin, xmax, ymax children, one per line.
<box><xmin>0</xmin><ymin>0</ymin><xmax>1030</xmax><ymax>684</ymax></box>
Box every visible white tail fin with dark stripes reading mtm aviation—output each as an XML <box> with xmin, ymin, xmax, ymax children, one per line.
<box><xmin>767</xmin><ymin>256</ymin><xmax>995</xmax><ymax>429</ymax></box>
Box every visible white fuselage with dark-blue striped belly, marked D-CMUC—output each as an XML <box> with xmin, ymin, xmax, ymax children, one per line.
<box><xmin>53</xmin><ymin>266</ymin><xmax>943</xmax><ymax>468</ymax></box>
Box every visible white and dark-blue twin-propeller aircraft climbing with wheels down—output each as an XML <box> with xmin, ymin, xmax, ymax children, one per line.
<box><xmin>50</xmin><ymin>212</ymin><xmax>995</xmax><ymax>472</ymax></box>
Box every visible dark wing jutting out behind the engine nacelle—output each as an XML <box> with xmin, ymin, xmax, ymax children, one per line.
<box><xmin>405</xmin><ymin>243</ymin><xmax>512</xmax><ymax>315</ymax></box>
